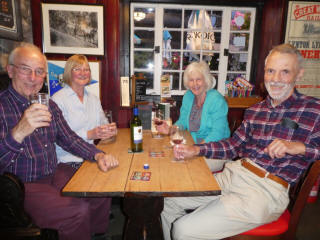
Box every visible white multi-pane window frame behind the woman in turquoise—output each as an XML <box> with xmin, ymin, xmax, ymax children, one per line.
<box><xmin>130</xmin><ymin>3</ymin><xmax>256</xmax><ymax>95</ymax></box>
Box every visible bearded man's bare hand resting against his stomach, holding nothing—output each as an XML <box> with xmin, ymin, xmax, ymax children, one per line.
<box><xmin>263</xmin><ymin>139</ymin><xmax>306</xmax><ymax>158</ymax></box>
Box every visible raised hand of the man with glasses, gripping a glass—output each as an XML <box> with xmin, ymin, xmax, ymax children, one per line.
<box><xmin>12</xmin><ymin>103</ymin><xmax>52</xmax><ymax>143</ymax></box>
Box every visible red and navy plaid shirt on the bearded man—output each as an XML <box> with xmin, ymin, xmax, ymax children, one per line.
<box><xmin>198</xmin><ymin>91</ymin><xmax>320</xmax><ymax>185</ymax></box>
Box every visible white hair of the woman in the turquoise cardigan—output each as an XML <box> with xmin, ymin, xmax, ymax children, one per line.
<box><xmin>183</xmin><ymin>61</ymin><xmax>216</xmax><ymax>91</ymax></box>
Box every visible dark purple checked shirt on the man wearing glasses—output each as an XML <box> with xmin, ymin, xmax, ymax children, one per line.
<box><xmin>0</xmin><ymin>85</ymin><xmax>101</xmax><ymax>182</ymax></box>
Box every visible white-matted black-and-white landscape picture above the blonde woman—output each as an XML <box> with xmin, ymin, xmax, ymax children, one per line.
<box><xmin>41</xmin><ymin>3</ymin><xmax>104</xmax><ymax>55</ymax></box>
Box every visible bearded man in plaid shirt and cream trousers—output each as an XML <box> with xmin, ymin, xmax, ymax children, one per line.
<box><xmin>161</xmin><ymin>44</ymin><xmax>320</xmax><ymax>240</ymax></box>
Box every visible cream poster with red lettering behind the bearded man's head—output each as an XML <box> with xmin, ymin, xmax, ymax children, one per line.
<box><xmin>285</xmin><ymin>1</ymin><xmax>320</xmax><ymax>98</ymax></box>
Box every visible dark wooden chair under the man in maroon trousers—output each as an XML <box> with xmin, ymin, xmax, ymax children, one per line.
<box><xmin>0</xmin><ymin>173</ymin><xmax>58</xmax><ymax>240</ymax></box>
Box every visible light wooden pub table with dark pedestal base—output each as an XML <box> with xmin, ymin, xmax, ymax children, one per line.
<box><xmin>62</xmin><ymin>129</ymin><xmax>220</xmax><ymax>240</ymax></box>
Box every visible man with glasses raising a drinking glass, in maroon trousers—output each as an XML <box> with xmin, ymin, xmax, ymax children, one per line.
<box><xmin>0</xmin><ymin>44</ymin><xmax>118</xmax><ymax>240</ymax></box>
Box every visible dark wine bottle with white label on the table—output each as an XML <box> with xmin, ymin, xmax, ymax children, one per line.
<box><xmin>130</xmin><ymin>106</ymin><xmax>142</xmax><ymax>152</ymax></box>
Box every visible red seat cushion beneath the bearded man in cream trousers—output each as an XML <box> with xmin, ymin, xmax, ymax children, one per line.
<box><xmin>240</xmin><ymin>210</ymin><xmax>290</xmax><ymax>236</ymax></box>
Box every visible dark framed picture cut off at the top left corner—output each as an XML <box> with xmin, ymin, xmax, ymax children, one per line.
<box><xmin>0</xmin><ymin>0</ymin><xmax>22</xmax><ymax>41</ymax></box>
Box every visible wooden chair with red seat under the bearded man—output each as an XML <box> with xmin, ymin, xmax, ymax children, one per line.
<box><xmin>225</xmin><ymin>160</ymin><xmax>320</xmax><ymax>240</ymax></box>
